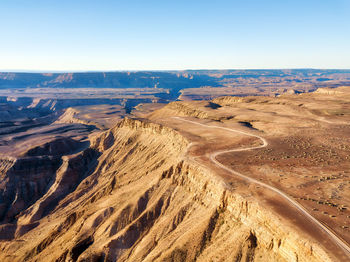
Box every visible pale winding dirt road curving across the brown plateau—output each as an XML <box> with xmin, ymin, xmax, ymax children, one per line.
<box><xmin>173</xmin><ymin>117</ymin><xmax>350</xmax><ymax>259</ymax></box>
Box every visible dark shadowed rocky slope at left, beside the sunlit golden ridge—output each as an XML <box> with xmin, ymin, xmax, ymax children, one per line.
<box><xmin>0</xmin><ymin>137</ymin><xmax>93</xmax><ymax>225</ymax></box>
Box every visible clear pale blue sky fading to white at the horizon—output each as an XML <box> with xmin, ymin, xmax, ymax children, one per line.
<box><xmin>0</xmin><ymin>0</ymin><xmax>350</xmax><ymax>71</ymax></box>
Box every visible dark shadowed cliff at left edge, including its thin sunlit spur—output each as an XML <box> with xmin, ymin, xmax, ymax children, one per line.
<box><xmin>0</xmin><ymin>137</ymin><xmax>98</xmax><ymax>228</ymax></box>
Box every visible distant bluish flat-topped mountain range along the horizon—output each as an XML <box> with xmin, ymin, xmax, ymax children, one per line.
<box><xmin>0</xmin><ymin>69</ymin><xmax>350</xmax><ymax>91</ymax></box>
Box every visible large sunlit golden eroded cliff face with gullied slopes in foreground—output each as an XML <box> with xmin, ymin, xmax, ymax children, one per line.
<box><xmin>0</xmin><ymin>118</ymin><xmax>331</xmax><ymax>261</ymax></box>
